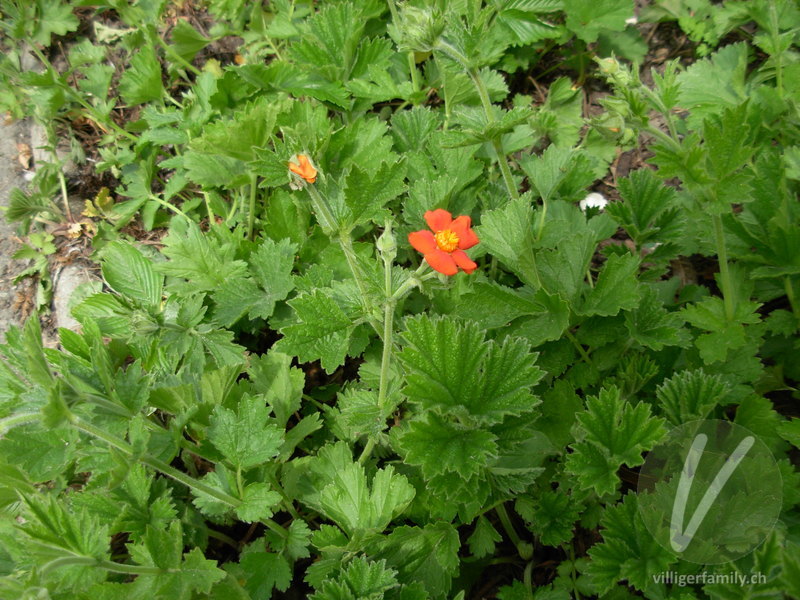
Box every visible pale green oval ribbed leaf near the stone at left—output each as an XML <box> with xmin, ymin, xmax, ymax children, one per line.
<box><xmin>102</xmin><ymin>241</ymin><xmax>164</xmax><ymax>308</ymax></box>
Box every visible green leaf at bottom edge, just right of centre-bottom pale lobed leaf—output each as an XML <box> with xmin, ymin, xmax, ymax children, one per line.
<box><xmin>374</xmin><ymin>521</ymin><xmax>460</xmax><ymax>597</ymax></box>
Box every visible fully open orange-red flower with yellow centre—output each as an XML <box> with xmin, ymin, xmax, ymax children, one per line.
<box><xmin>408</xmin><ymin>208</ymin><xmax>479</xmax><ymax>275</ymax></box>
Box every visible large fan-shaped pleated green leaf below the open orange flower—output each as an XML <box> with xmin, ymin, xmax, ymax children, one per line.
<box><xmin>400</xmin><ymin>315</ymin><xmax>543</xmax><ymax>424</ymax></box>
